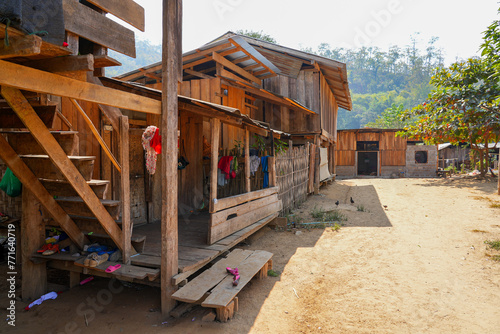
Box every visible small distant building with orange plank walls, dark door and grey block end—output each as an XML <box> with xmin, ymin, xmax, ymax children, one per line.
<box><xmin>336</xmin><ymin>128</ymin><xmax>438</xmax><ymax>177</ymax></box>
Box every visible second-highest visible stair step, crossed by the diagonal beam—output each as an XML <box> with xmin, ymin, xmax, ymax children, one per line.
<box><xmin>2</xmin><ymin>131</ymin><xmax>78</xmax><ymax>155</ymax></box>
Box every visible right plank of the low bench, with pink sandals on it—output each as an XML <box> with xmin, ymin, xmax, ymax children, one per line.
<box><xmin>201</xmin><ymin>251</ymin><xmax>273</xmax><ymax>308</ymax></box>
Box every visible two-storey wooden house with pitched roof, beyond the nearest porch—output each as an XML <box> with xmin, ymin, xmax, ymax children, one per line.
<box><xmin>117</xmin><ymin>32</ymin><xmax>352</xmax><ymax>184</ymax></box>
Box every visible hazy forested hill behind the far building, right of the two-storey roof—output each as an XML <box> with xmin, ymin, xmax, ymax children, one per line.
<box><xmin>304</xmin><ymin>38</ymin><xmax>444</xmax><ymax>129</ymax></box>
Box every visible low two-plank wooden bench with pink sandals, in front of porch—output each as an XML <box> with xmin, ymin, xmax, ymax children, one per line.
<box><xmin>172</xmin><ymin>249</ymin><xmax>273</xmax><ymax>322</ymax></box>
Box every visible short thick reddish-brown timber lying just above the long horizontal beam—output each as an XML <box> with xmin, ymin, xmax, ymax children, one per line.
<box><xmin>23</xmin><ymin>54</ymin><xmax>94</xmax><ymax>73</ymax></box>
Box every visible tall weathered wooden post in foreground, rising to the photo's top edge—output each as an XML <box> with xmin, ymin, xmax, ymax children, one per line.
<box><xmin>160</xmin><ymin>0</ymin><xmax>182</xmax><ymax>319</ymax></box>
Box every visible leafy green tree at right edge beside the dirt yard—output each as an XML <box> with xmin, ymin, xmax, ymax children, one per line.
<box><xmin>404</xmin><ymin>58</ymin><xmax>500</xmax><ymax>175</ymax></box>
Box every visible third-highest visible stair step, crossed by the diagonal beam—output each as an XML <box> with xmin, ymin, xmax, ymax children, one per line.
<box><xmin>20</xmin><ymin>154</ymin><xmax>95</xmax><ymax>181</ymax></box>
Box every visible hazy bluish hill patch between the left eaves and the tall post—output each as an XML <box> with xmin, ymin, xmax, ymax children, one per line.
<box><xmin>106</xmin><ymin>40</ymin><xmax>161</xmax><ymax>77</ymax></box>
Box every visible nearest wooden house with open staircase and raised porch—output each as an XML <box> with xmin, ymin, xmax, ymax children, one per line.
<box><xmin>0</xmin><ymin>0</ymin><xmax>282</xmax><ymax>318</ymax></box>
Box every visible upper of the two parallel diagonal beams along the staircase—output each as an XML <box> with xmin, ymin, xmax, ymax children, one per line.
<box><xmin>2</xmin><ymin>86</ymin><xmax>131</xmax><ymax>253</ymax></box>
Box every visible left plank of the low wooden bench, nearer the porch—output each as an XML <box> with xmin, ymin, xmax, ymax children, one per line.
<box><xmin>172</xmin><ymin>249</ymin><xmax>253</xmax><ymax>303</ymax></box>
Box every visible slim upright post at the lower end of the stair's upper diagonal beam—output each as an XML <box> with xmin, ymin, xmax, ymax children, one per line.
<box><xmin>118</xmin><ymin>116</ymin><xmax>132</xmax><ymax>264</ymax></box>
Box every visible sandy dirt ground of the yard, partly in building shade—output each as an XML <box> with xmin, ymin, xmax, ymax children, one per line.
<box><xmin>0</xmin><ymin>179</ymin><xmax>500</xmax><ymax>334</ymax></box>
